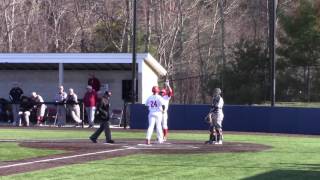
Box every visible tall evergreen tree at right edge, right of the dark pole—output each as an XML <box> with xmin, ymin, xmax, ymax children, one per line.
<box><xmin>277</xmin><ymin>0</ymin><xmax>320</xmax><ymax>101</ymax></box>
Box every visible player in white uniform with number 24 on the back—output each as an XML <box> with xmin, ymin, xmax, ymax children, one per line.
<box><xmin>146</xmin><ymin>86</ymin><xmax>164</xmax><ymax>145</ymax></box>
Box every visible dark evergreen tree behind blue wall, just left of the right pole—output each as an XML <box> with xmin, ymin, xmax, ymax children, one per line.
<box><xmin>215</xmin><ymin>40</ymin><xmax>270</xmax><ymax>104</ymax></box>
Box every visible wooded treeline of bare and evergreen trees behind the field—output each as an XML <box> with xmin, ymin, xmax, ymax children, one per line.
<box><xmin>0</xmin><ymin>0</ymin><xmax>320</xmax><ymax>104</ymax></box>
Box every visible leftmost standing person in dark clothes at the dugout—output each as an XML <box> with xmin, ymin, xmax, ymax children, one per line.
<box><xmin>9</xmin><ymin>82</ymin><xmax>23</xmax><ymax>126</ymax></box>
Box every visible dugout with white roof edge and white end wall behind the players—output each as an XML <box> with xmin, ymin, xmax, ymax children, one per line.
<box><xmin>0</xmin><ymin>53</ymin><xmax>167</xmax><ymax>109</ymax></box>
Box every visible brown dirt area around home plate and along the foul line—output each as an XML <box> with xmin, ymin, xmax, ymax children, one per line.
<box><xmin>0</xmin><ymin>140</ymin><xmax>271</xmax><ymax>176</ymax></box>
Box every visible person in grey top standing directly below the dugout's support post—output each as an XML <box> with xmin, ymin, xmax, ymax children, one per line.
<box><xmin>55</xmin><ymin>86</ymin><xmax>68</xmax><ymax>127</ymax></box>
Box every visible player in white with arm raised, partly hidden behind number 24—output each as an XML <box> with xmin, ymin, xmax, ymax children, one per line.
<box><xmin>160</xmin><ymin>80</ymin><xmax>173</xmax><ymax>141</ymax></box>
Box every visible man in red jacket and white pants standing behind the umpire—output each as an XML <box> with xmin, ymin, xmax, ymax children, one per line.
<box><xmin>83</xmin><ymin>86</ymin><xmax>98</xmax><ymax>128</ymax></box>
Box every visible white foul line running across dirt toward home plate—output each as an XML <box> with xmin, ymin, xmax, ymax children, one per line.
<box><xmin>0</xmin><ymin>147</ymin><xmax>132</xmax><ymax>169</ymax></box>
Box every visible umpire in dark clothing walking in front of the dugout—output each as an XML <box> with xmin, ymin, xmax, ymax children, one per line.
<box><xmin>89</xmin><ymin>91</ymin><xmax>114</xmax><ymax>143</ymax></box>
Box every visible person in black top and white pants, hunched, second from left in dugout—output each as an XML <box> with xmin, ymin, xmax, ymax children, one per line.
<box><xmin>17</xmin><ymin>96</ymin><xmax>34</xmax><ymax>126</ymax></box>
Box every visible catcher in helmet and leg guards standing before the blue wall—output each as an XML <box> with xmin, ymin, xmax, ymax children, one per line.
<box><xmin>205</xmin><ymin>88</ymin><xmax>224</xmax><ymax>144</ymax></box>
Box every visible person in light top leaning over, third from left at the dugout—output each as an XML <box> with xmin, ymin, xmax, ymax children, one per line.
<box><xmin>31</xmin><ymin>92</ymin><xmax>47</xmax><ymax>126</ymax></box>
